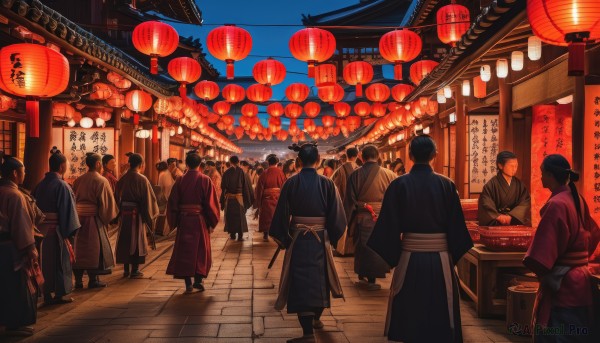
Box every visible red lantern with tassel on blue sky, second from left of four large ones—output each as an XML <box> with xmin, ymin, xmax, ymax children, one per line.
<box><xmin>206</xmin><ymin>25</ymin><xmax>252</xmax><ymax>80</ymax></box>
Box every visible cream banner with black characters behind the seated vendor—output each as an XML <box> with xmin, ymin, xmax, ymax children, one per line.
<box><xmin>468</xmin><ymin>114</ymin><xmax>500</xmax><ymax>193</ymax></box>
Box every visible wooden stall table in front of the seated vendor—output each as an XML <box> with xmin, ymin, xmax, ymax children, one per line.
<box><xmin>457</xmin><ymin>244</ymin><xmax>535</xmax><ymax>317</ymax></box>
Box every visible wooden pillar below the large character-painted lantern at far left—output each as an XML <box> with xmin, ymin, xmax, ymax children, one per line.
<box><xmin>23</xmin><ymin>101</ymin><xmax>52</xmax><ymax>190</ymax></box>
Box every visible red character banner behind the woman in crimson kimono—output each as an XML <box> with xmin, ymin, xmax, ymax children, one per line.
<box><xmin>530</xmin><ymin>104</ymin><xmax>573</xmax><ymax>226</ymax></box>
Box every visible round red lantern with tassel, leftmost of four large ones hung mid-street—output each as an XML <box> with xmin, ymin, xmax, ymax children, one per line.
<box><xmin>131</xmin><ymin>21</ymin><xmax>179</xmax><ymax>74</ymax></box>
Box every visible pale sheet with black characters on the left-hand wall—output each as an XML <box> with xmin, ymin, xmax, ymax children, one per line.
<box><xmin>63</xmin><ymin>128</ymin><xmax>115</xmax><ymax>181</ymax></box>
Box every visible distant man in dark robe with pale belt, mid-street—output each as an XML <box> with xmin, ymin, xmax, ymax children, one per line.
<box><xmin>221</xmin><ymin>156</ymin><xmax>254</xmax><ymax>241</ymax></box>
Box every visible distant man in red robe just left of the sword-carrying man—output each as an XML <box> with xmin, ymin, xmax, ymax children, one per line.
<box><xmin>255</xmin><ymin>154</ymin><xmax>285</xmax><ymax>241</ymax></box>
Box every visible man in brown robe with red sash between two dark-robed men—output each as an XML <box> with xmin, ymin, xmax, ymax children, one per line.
<box><xmin>344</xmin><ymin>145</ymin><xmax>396</xmax><ymax>291</ymax></box>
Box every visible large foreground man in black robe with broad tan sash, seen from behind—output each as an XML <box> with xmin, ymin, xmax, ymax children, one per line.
<box><xmin>367</xmin><ymin>135</ymin><xmax>473</xmax><ymax>343</ymax></box>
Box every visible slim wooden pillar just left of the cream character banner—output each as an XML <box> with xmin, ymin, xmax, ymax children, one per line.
<box><xmin>454</xmin><ymin>87</ymin><xmax>468</xmax><ymax>198</ymax></box>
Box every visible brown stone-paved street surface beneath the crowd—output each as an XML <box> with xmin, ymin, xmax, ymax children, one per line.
<box><xmin>0</xmin><ymin>218</ymin><xmax>529</xmax><ymax>343</ymax></box>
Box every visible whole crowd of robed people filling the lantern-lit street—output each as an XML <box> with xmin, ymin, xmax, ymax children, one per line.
<box><xmin>0</xmin><ymin>135</ymin><xmax>600</xmax><ymax>342</ymax></box>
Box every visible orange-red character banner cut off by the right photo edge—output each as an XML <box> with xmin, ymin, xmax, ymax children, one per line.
<box><xmin>583</xmin><ymin>85</ymin><xmax>600</xmax><ymax>226</ymax></box>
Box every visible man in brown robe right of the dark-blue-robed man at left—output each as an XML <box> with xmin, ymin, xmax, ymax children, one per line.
<box><xmin>73</xmin><ymin>153</ymin><xmax>117</xmax><ymax>288</ymax></box>
